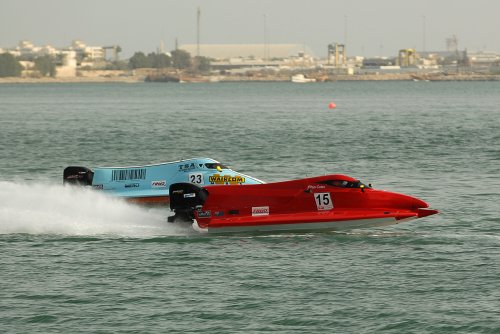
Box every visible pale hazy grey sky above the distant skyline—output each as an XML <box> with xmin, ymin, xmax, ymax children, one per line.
<box><xmin>0</xmin><ymin>0</ymin><xmax>500</xmax><ymax>57</ymax></box>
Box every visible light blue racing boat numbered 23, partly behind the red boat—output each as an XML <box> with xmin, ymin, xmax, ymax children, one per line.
<box><xmin>63</xmin><ymin>158</ymin><xmax>264</xmax><ymax>205</ymax></box>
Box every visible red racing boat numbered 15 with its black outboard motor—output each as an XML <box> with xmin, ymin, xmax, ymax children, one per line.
<box><xmin>169</xmin><ymin>174</ymin><xmax>438</xmax><ymax>233</ymax></box>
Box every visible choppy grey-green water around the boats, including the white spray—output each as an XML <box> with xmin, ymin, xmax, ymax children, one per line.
<box><xmin>0</xmin><ymin>82</ymin><xmax>500</xmax><ymax>333</ymax></box>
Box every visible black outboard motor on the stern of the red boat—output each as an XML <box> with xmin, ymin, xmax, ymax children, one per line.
<box><xmin>168</xmin><ymin>183</ymin><xmax>208</xmax><ymax>223</ymax></box>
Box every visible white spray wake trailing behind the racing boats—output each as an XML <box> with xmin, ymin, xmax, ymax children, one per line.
<box><xmin>0</xmin><ymin>181</ymin><xmax>188</xmax><ymax>238</ymax></box>
